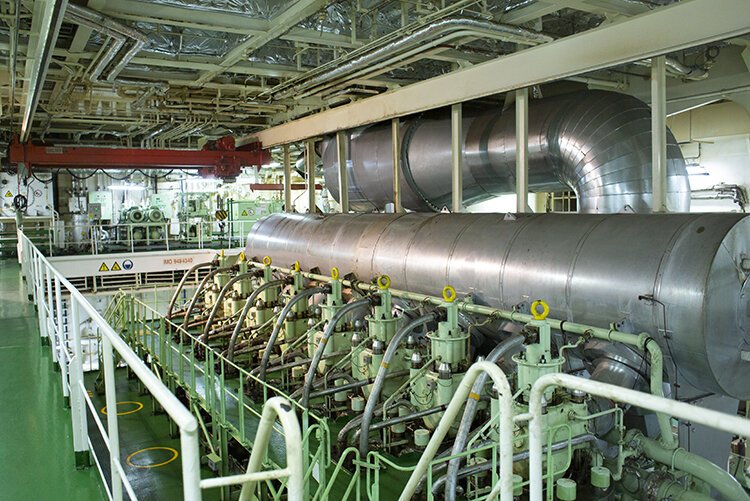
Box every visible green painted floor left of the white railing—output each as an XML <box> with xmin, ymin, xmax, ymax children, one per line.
<box><xmin>0</xmin><ymin>259</ymin><xmax>106</xmax><ymax>501</ymax></box>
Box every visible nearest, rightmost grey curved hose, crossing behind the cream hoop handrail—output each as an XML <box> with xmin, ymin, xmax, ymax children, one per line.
<box><xmin>445</xmin><ymin>334</ymin><xmax>524</xmax><ymax>501</ymax></box>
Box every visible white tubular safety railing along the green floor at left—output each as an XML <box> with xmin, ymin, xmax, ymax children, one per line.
<box><xmin>18</xmin><ymin>229</ymin><xmax>304</xmax><ymax>501</ymax></box>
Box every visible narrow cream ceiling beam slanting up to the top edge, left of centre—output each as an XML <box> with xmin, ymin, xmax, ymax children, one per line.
<box><xmin>195</xmin><ymin>0</ymin><xmax>331</xmax><ymax>85</ymax></box>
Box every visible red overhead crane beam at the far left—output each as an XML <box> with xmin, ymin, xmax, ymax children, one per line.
<box><xmin>8</xmin><ymin>137</ymin><xmax>271</xmax><ymax>178</ymax></box>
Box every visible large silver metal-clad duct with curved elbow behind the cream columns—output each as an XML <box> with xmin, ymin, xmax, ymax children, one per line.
<box><xmin>323</xmin><ymin>91</ymin><xmax>690</xmax><ymax>212</ymax></box>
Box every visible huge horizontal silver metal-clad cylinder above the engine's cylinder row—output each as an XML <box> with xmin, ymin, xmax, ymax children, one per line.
<box><xmin>250</xmin><ymin>213</ymin><xmax>750</xmax><ymax>399</ymax></box>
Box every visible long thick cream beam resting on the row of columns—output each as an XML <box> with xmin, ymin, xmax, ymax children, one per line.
<box><xmin>250</xmin><ymin>0</ymin><xmax>750</xmax><ymax>147</ymax></box>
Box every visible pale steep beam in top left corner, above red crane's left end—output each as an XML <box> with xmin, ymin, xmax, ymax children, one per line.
<box><xmin>16</xmin><ymin>0</ymin><xmax>68</xmax><ymax>143</ymax></box>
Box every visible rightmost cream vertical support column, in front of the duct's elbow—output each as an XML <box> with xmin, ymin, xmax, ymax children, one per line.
<box><xmin>651</xmin><ymin>56</ymin><xmax>667</xmax><ymax>212</ymax></box>
